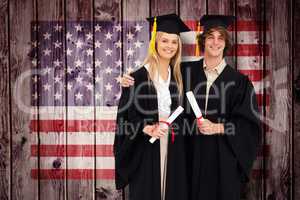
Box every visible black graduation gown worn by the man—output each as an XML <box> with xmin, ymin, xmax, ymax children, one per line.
<box><xmin>182</xmin><ymin>59</ymin><xmax>261</xmax><ymax>200</ymax></box>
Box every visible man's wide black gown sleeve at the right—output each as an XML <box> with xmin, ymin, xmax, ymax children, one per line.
<box><xmin>224</xmin><ymin>76</ymin><xmax>261</xmax><ymax>181</ymax></box>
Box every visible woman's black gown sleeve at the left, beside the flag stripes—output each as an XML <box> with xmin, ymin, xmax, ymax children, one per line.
<box><xmin>114</xmin><ymin>79</ymin><xmax>150</xmax><ymax>189</ymax></box>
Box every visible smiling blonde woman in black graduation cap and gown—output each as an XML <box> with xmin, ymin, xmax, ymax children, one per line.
<box><xmin>114</xmin><ymin>14</ymin><xmax>189</xmax><ymax>200</ymax></box>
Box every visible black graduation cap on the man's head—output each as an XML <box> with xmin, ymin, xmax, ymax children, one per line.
<box><xmin>200</xmin><ymin>15</ymin><xmax>235</xmax><ymax>33</ymax></box>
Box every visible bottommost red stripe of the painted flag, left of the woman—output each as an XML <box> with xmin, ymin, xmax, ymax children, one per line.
<box><xmin>31</xmin><ymin>169</ymin><xmax>115</xmax><ymax>180</ymax></box>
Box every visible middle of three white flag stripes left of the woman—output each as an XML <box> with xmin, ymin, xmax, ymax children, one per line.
<box><xmin>31</xmin><ymin>132</ymin><xmax>115</xmax><ymax>145</ymax></box>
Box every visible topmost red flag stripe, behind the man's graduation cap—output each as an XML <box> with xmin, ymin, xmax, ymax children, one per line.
<box><xmin>184</xmin><ymin>20</ymin><xmax>269</xmax><ymax>31</ymax></box>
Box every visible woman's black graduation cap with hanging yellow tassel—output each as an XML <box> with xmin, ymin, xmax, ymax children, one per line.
<box><xmin>147</xmin><ymin>13</ymin><xmax>190</xmax><ymax>53</ymax></box>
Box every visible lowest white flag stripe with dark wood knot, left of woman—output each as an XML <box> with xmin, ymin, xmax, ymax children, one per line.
<box><xmin>30</xmin><ymin>157</ymin><xmax>115</xmax><ymax>169</ymax></box>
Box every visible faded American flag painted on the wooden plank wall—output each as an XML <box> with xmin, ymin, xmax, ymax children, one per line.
<box><xmin>30</xmin><ymin>21</ymin><xmax>268</xmax><ymax>183</ymax></box>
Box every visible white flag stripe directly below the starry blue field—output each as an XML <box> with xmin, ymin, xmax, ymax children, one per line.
<box><xmin>31</xmin><ymin>106</ymin><xmax>117</xmax><ymax>120</ymax></box>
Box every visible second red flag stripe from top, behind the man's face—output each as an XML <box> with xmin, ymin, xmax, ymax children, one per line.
<box><xmin>182</xmin><ymin>44</ymin><xmax>269</xmax><ymax>56</ymax></box>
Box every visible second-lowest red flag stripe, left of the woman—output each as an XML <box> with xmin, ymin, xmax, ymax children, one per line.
<box><xmin>31</xmin><ymin>144</ymin><xmax>113</xmax><ymax>157</ymax></box>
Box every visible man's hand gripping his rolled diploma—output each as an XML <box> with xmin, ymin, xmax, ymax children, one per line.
<box><xmin>197</xmin><ymin>119</ymin><xmax>224</xmax><ymax>135</ymax></box>
